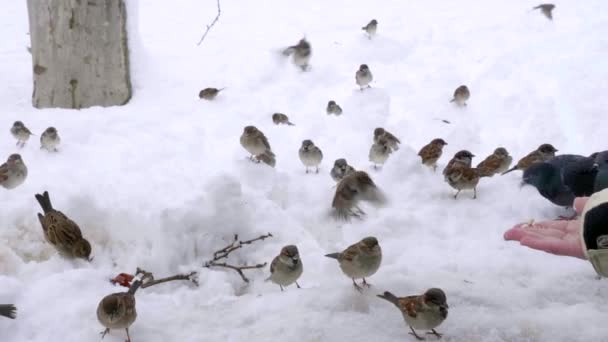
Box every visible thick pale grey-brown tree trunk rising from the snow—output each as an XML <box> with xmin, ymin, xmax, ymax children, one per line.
<box><xmin>27</xmin><ymin>0</ymin><xmax>131</xmax><ymax>109</ymax></box>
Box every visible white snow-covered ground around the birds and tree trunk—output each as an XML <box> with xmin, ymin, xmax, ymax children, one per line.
<box><xmin>0</xmin><ymin>0</ymin><xmax>608</xmax><ymax>342</ymax></box>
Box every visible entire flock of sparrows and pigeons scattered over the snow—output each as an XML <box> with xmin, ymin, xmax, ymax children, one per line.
<box><xmin>0</xmin><ymin>4</ymin><xmax>608</xmax><ymax>341</ymax></box>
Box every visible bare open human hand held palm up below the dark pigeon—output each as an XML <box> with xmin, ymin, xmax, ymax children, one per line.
<box><xmin>504</xmin><ymin>197</ymin><xmax>588</xmax><ymax>259</ymax></box>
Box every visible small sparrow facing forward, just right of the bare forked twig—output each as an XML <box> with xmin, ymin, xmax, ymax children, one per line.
<box><xmin>266</xmin><ymin>245</ymin><xmax>304</xmax><ymax>291</ymax></box>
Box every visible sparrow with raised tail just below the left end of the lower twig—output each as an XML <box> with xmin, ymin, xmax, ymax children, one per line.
<box><xmin>97</xmin><ymin>280</ymin><xmax>141</xmax><ymax>342</ymax></box>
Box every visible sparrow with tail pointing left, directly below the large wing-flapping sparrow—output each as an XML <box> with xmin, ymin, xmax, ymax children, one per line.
<box><xmin>325</xmin><ymin>236</ymin><xmax>382</xmax><ymax>291</ymax></box>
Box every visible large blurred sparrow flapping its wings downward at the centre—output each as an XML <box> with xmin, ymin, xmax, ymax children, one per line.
<box><xmin>332</xmin><ymin>171</ymin><xmax>384</xmax><ymax>220</ymax></box>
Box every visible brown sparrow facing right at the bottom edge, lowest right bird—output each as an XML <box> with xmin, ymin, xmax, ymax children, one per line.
<box><xmin>378</xmin><ymin>288</ymin><xmax>449</xmax><ymax>340</ymax></box>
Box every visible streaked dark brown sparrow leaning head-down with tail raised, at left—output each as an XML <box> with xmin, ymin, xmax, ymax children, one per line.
<box><xmin>36</xmin><ymin>191</ymin><xmax>92</xmax><ymax>261</ymax></box>
